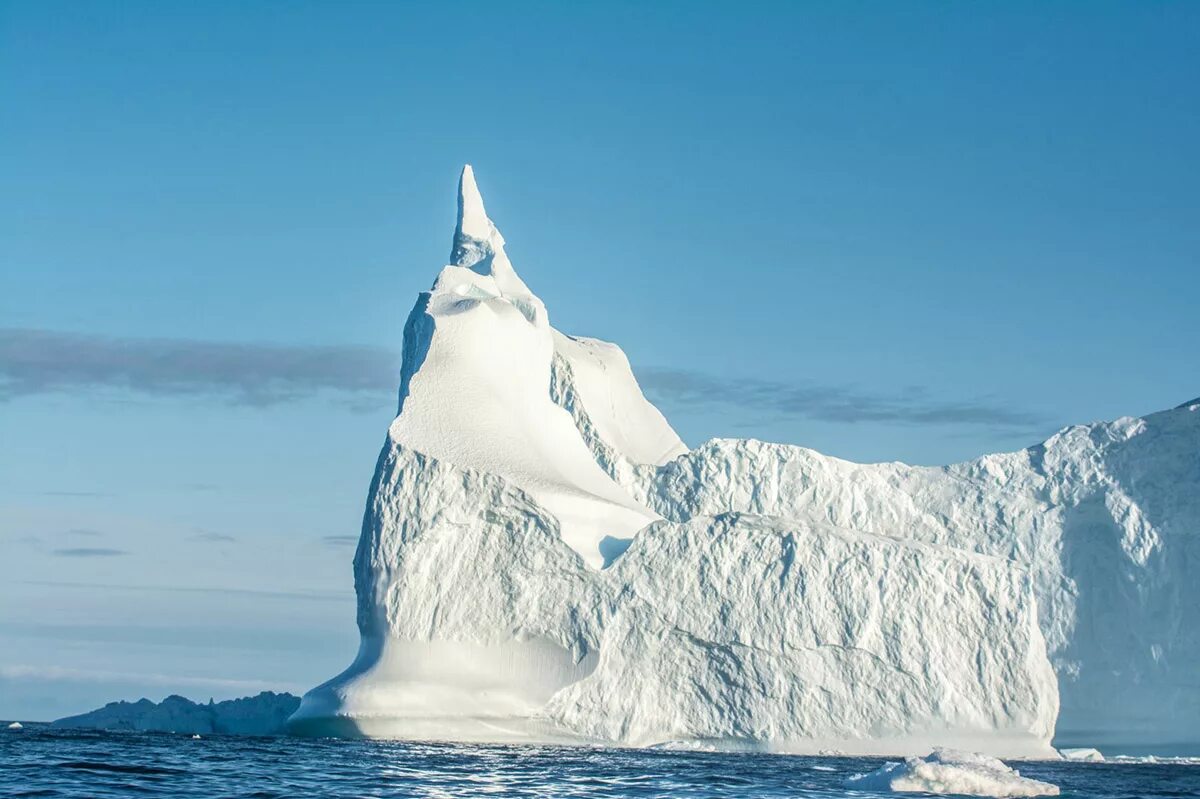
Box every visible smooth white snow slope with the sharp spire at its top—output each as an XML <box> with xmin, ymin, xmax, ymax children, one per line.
<box><xmin>381</xmin><ymin>168</ymin><xmax>658</xmax><ymax>566</ymax></box>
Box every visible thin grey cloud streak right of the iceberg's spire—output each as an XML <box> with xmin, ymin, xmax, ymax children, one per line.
<box><xmin>637</xmin><ymin>368</ymin><xmax>1046</xmax><ymax>431</ymax></box>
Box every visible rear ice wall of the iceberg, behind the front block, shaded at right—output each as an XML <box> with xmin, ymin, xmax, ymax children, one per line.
<box><xmin>619</xmin><ymin>404</ymin><xmax>1200</xmax><ymax>749</ymax></box>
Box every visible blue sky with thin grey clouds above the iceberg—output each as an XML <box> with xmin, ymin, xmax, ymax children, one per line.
<box><xmin>0</xmin><ymin>2</ymin><xmax>1200</xmax><ymax>719</ymax></box>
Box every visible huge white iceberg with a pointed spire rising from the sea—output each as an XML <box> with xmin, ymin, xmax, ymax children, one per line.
<box><xmin>289</xmin><ymin>167</ymin><xmax>1200</xmax><ymax>756</ymax></box>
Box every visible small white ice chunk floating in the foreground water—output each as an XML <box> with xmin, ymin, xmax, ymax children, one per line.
<box><xmin>846</xmin><ymin>749</ymin><xmax>1058</xmax><ymax>797</ymax></box>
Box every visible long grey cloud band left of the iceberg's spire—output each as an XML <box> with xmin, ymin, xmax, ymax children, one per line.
<box><xmin>0</xmin><ymin>329</ymin><xmax>400</xmax><ymax>409</ymax></box>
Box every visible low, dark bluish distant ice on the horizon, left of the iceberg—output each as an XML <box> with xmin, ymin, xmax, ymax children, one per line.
<box><xmin>50</xmin><ymin>691</ymin><xmax>300</xmax><ymax>735</ymax></box>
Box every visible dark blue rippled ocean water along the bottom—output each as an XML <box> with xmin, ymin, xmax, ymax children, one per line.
<box><xmin>0</xmin><ymin>727</ymin><xmax>1200</xmax><ymax>799</ymax></box>
